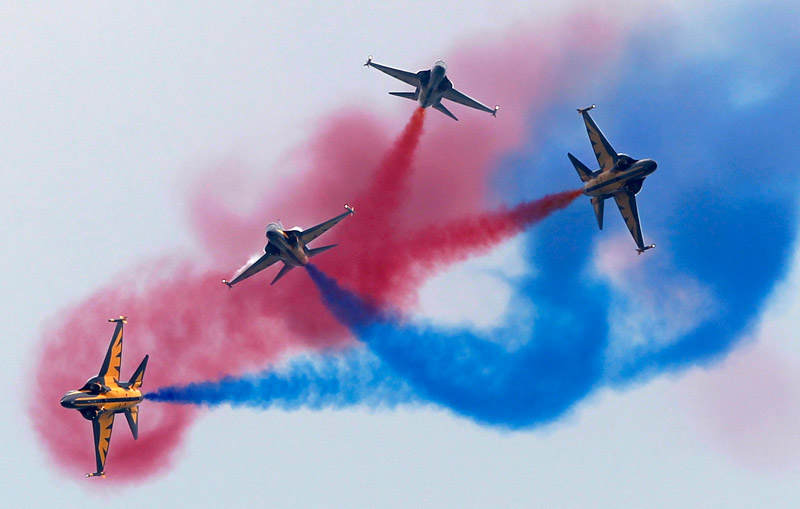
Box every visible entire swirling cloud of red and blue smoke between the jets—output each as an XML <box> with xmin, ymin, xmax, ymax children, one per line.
<box><xmin>31</xmin><ymin>3</ymin><xmax>800</xmax><ymax>480</ymax></box>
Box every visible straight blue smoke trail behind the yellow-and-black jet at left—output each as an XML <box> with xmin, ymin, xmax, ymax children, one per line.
<box><xmin>145</xmin><ymin>350</ymin><xmax>417</xmax><ymax>410</ymax></box>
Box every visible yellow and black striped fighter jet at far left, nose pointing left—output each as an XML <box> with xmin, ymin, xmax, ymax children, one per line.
<box><xmin>61</xmin><ymin>316</ymin><xmax>150</xmax><ymax>477</ymax></box>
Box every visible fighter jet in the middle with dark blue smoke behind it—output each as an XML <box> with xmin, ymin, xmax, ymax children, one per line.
<box><xmin>222</xmin><ymin>204</ymin><xmax>355</xmax><ymax>288</ymax></box>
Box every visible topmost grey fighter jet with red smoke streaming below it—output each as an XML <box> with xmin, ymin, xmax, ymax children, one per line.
<box><xmin>364</xmin><ymin>55</ymin><xmax>500</xmax><ymax>120</ymax></box>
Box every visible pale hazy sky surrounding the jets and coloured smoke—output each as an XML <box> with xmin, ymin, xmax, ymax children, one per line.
<box><xmin>0</xmin><ymin>1</ymin><xmax>800</xmax><ymax>507</ymax></box>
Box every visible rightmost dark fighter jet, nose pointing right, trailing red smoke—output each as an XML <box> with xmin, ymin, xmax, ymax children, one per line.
<box><xmin>567</xmin><ymin>104</ymin><xmax>658</xmax><ymax>254</ymax></box>
